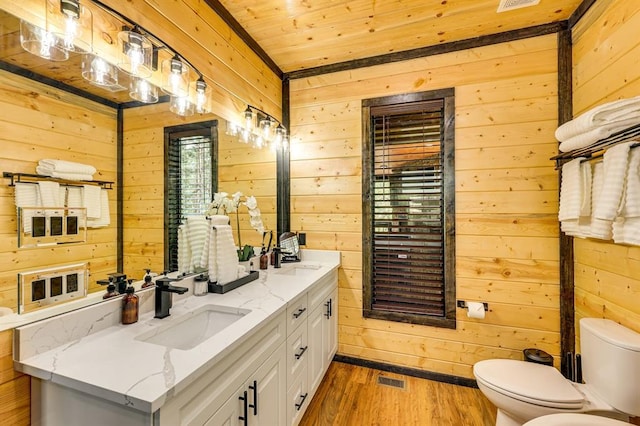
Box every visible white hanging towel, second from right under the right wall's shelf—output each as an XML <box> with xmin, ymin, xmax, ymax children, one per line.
<box><xmin>593</xmin><ymin>142</ymin><xmax>632</xmax><ymax>221</ymax></box>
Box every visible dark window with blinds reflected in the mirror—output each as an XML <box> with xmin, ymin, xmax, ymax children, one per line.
<box><xmin>165</xmin><ymin>121</ymin><xmax>218</xmax><ymax>271</ymax></box>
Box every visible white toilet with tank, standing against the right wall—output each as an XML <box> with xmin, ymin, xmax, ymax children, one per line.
<box><xmin>473</xmin><ymin>318</ymin><xmax>640</xmax><ymax>426</ymax></box>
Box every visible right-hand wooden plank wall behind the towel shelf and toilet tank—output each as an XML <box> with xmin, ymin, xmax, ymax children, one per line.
<box><xmin>572</xmin><ymin>0</ymin><xmax>640</xmax><ymax>335</ymax></box>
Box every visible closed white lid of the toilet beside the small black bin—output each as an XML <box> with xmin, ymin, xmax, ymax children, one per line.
<box><xmin>473</xmin><ymin>359</ymin><xmax>584</xmax><ymax>409</ymax></box>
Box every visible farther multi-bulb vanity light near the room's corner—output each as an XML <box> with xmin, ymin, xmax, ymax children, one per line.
<box><xmin>226</xmin><ymin>105</ymin><xmax>289</xmax><ymax>150</ymax></box>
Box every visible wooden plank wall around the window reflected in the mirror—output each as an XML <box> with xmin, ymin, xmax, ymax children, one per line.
<box><xmin>123</xmin><ymin>103</ymin><xmax>276</xmax><ymax>278</ymax></box>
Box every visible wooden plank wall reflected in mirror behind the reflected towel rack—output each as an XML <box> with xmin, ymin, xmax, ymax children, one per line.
<box><xmin>0</xmin><ymin>71</ymin><xmax>118</xmax><ymax>310</ymax></box>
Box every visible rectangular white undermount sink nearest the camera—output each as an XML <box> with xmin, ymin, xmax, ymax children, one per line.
<box><xmin>136</xmin><ymin>305</ymin><xmax>251</xmax><ymax>350</ymax></box>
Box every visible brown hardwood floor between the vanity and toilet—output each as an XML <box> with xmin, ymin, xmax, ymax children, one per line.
<box><xmin>300</xmin><ymin>361</ymin><xmax>496</xmax><ymax>426</ymax></box>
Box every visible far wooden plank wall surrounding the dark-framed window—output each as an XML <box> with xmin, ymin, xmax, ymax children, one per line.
<box><xmin>291</xmin><ymin>35</ymin><xmax>560</xmax><ymax>377</ymax></box>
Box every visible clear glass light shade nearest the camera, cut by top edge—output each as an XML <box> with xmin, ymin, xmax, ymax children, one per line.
<box><xmin>46</xmin><ymin>0</ymin><xmax>93</xmax><ymax>52</ymax></box>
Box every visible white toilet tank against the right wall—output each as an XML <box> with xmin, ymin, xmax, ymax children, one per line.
<box><xmin>580</xmin><ymin>318</ymin><xmax>640</xmax><ymax>416</ymax></box>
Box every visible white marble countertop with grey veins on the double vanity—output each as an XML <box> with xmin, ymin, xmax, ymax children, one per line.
<box><xmin>14</xmin><ymin>250</ymin><xmax>340</xmax><ymax>413</ymax></box>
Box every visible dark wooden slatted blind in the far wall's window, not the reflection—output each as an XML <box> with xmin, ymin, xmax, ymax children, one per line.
<box><xmin>365</xmin><ymin>90</ymin><xmax>453</xmax><ymax>330</ymax></box>
